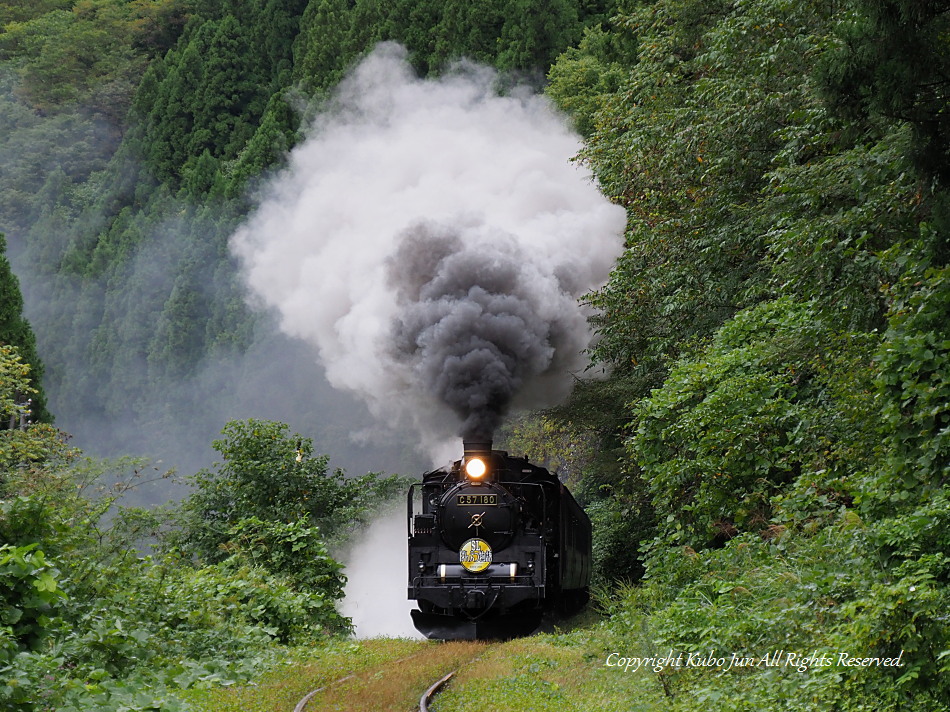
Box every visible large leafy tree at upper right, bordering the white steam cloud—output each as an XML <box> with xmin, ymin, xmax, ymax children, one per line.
<box><xmin>549</xmin><ymin>0</ymin><xmax>916</xmax><ymax>444</ymax></box>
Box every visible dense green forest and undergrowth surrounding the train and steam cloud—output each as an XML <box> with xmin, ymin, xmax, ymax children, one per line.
<box><xmin>0</xmin><ymin>0</ymin><xmax>950</xmax><ymax>710</ymax></box>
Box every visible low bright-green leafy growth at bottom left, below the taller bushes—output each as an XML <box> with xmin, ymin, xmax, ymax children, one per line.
<box><xmin>0</xmin><ymin>547</ymin><xmax>340</xmax><ymax>711</ymax></box>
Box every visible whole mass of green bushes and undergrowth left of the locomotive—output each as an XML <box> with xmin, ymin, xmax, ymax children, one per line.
<box><xmin>0</xmin><ymin>349</ymin><xmax>402</xmax><ymax>712</ymax></box>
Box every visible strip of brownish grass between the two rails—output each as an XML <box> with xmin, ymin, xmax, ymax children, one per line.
<box><xmin>293</xmin><ymin>641</ymin><xmax>489</xmax><ymax>712</ymax></box>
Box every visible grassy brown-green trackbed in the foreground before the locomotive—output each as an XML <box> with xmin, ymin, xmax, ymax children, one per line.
<box><xmin>187</xmin><ymin>608</ymin><xmax>663</xmax><ymax>712</ymax></box>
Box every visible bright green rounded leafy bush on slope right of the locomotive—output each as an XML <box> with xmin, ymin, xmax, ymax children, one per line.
<box><xmin>629</xmin><ymin>299</ymin><xmax>875</xmax><ymax>548</ymax></box>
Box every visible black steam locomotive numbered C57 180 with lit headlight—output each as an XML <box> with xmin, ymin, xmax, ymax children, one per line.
<box><xmin>409</xmin><ymin>442</ymin><xmax>591</xmax><ymax>640</ymax></box>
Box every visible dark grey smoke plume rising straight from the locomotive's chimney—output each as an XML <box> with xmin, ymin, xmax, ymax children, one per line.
<box><xmin>388</xmin><ymin>223</ymin><xmax>582</xmax><ymax>440</ymax></box>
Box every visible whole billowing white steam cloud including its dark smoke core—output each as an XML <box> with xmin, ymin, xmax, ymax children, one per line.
<box><xmin>232</xmin><ymin>44</ymin><xmax>625</xmax><ymax>452</ymax></box>
